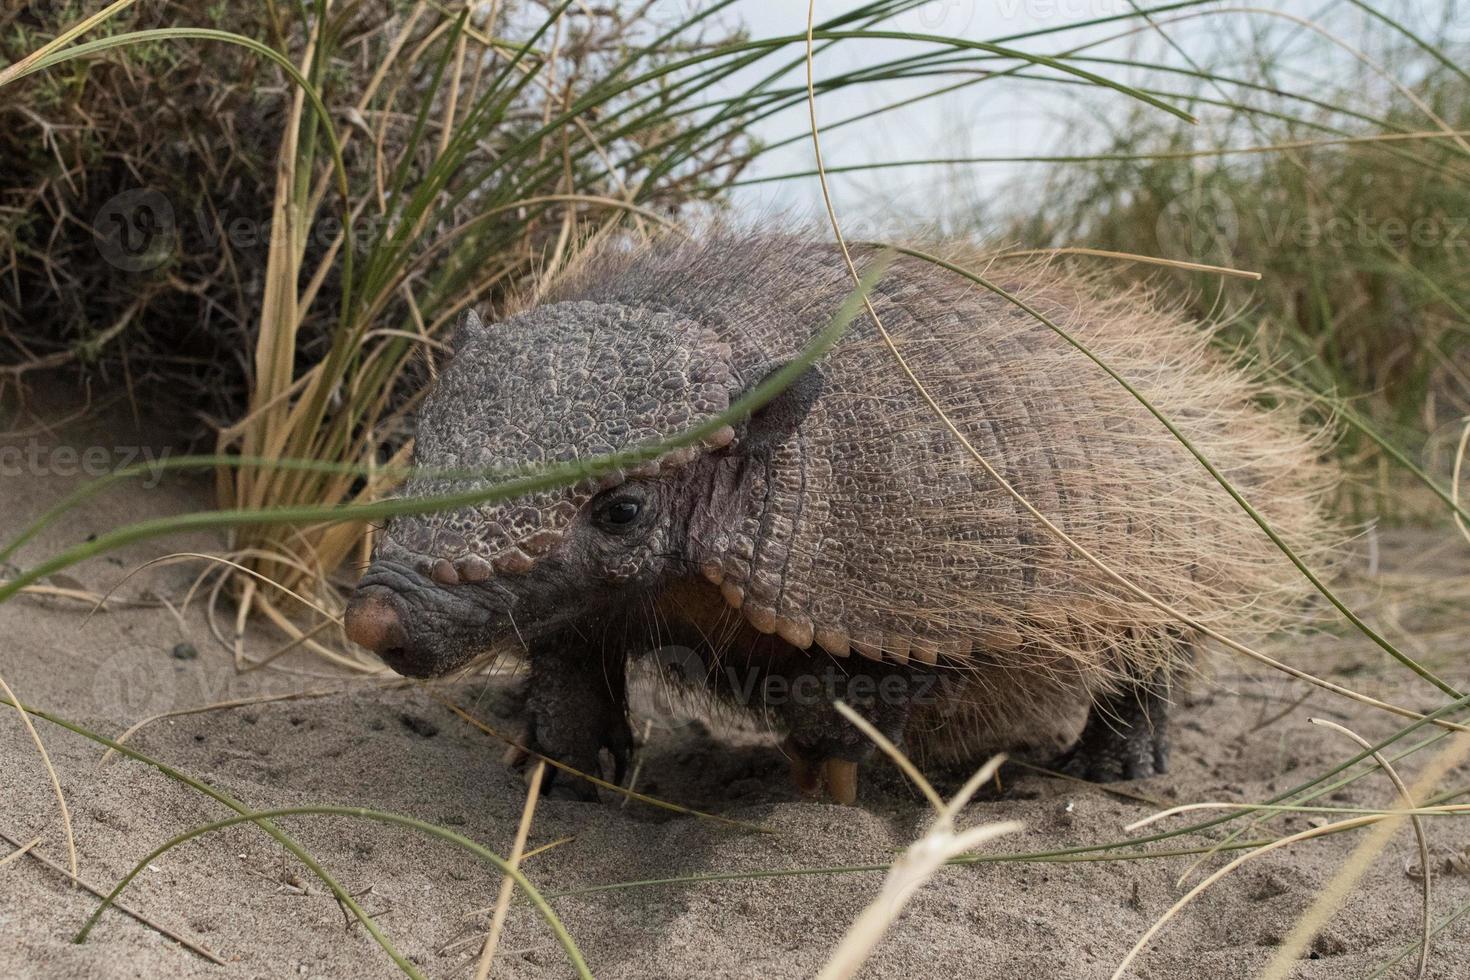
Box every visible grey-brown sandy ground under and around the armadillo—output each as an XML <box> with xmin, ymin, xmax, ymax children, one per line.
<box><xmin>0</xmin><ymin>399</ymin><xmax>1470</xmax><ymax>980</ymax></box>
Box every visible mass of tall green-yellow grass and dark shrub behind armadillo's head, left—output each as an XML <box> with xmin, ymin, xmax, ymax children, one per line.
<box><xmin>0</xmin><ymin>1</ymin><xmax>748</xmax><ymax>658</ymax></box>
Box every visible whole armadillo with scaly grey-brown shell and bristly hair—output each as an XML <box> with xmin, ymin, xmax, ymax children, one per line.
<box><xmin>345</xmin><ymin>232</ymin><xmax>1341</xmax><ymax>802</ymax></box>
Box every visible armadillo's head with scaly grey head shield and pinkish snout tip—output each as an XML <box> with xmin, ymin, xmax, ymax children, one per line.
<box><xmin>338</xmin><ymin>303</ymin><xmax>811</xmax><ymax>676</ymax></box>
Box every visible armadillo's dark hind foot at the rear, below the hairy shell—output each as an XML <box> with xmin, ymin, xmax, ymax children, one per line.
<box><xmin>1054</xmin><ymin>674</ymin><xmax>1169</xmax><ymax>783</ymax></box>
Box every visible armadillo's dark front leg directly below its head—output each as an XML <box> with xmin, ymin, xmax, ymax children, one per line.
<box><xmin>523</xmin><ymin>635</ymin><xmax>634</xmax><ymax>801</ymax></box>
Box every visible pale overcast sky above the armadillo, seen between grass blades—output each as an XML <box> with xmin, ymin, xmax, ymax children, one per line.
<box><xmin>708</xmin><ymin>0</ymin><xmax>1470</xmax><ymax>227</ymax></box>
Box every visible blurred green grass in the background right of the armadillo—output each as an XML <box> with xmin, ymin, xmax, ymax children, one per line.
<box><xmin>982</xmin><ymin>41</ymin><xmax>1470</xmax><ymax>513</ymax></box>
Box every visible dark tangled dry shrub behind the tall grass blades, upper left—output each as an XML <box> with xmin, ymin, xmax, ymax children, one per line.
<box><xmin>0</xmin><ymin>0</ymin><xmax>744</xmax><ymax>423</ymax></box>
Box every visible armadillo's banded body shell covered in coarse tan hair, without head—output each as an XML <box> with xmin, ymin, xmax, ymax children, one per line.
<box><xmin>547</xmin><ymin>231</ymin><xmax>1344</xmax><ymax>734</ymax></box>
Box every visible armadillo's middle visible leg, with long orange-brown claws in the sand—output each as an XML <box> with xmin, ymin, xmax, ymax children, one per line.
<box><xmin>766</xmin><ymin>657</ymin><xmax>929</xmax><ymax>805</ymax></box>
